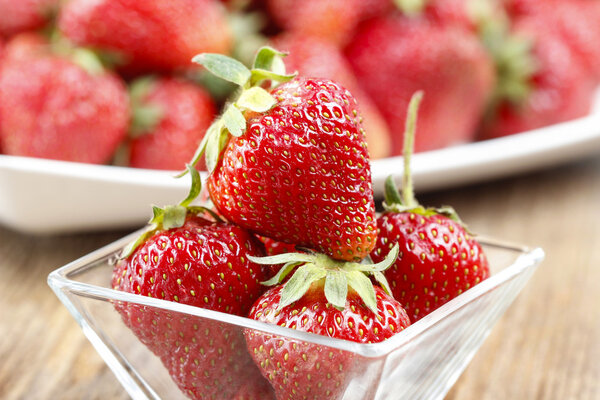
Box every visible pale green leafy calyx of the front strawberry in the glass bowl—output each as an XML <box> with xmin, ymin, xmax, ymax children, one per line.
<box><xmin>248</xmin><ymin>244</ymin><xmax>399</xmax><ymax>314</ymax></box>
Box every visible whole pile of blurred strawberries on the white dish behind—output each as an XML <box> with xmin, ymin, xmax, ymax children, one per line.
<box><xmin>0</xmin><ymin>0</ymin><xmax>600</xmax><ymax>170</ymax></box>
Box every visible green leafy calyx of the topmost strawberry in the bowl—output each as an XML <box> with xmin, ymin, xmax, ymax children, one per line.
<box><xmin>179</xmin><ymin>46</ymin><xmax>296</xmax><ymax>176</ymax></box>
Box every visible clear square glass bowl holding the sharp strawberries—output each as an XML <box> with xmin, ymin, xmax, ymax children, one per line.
<box><xmin>48</xmin><ymin>233</ymin><xmax>544</xmax><ymax>400</ymax></box>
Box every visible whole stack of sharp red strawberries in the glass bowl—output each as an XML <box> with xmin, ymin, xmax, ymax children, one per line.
<box><xmin>112</xmin><ymin>47</ymin><xmax>490</xmax><ymax>400</ymax></box>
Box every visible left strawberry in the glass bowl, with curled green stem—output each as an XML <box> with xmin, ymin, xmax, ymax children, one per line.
<box><xmin>112</xmin><ymin>168</ymin><xmax>274</xmax><ymax>399</ymax></box>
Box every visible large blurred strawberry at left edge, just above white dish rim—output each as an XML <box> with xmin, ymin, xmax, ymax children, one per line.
<box><xmin>0</xmin><ymin>43</ymin><xmax>129</xmax><ymax>163</ymax></box>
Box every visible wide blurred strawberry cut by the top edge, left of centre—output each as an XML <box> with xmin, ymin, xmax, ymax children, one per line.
<box><xmin>59</xmin><ymin>0</ymin><xmax>231</xmax><ymax>73</ymax></box>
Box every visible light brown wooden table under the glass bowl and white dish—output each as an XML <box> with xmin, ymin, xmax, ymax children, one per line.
<box><xmin>0</xmin><ymin>157</ymin><xmax>600</xmax><ymax>400</ymax></box>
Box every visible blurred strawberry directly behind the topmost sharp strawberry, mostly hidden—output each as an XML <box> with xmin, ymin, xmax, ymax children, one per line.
<box><xmin>274</xmin><ymin>34</ymin><xmax>391</xmax><ymax>159</ymax></box>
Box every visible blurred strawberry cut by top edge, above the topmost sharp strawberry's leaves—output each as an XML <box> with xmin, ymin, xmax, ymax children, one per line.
<box><xmin>267</xmin><ymin>0</ymin><xmax>362</xmax><ymax>45</ymax></box>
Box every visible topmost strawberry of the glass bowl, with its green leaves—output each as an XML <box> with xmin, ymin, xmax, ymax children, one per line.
<box><xmin>190</xmin><ymin>48</ymin><xmax>376</xmax><ymax>260</ymax></box>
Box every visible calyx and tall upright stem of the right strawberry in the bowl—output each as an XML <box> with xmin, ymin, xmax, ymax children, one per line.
<box><xmin>383</xmin><ymin>91</ymin><xmax>466</xmax><ymax>229</ymax></box>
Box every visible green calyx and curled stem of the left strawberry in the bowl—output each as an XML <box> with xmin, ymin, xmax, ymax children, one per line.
<box><xmin>120</xmin><ymin>165</ymin><xmax>221</xmax><ymax>259</ymax></box>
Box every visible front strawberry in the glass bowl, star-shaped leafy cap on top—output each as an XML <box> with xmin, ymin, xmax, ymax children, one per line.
<box><xmin>245</xmin><ymin>246</ymin><xmax>410</xmax><ymax>400</ymax></box>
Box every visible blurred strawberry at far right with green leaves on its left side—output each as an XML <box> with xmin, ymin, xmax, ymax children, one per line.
<box><xmin>482</xmin><ymin>17</ymin><xmax>595</xmax><ymax>138</ymax></box>
